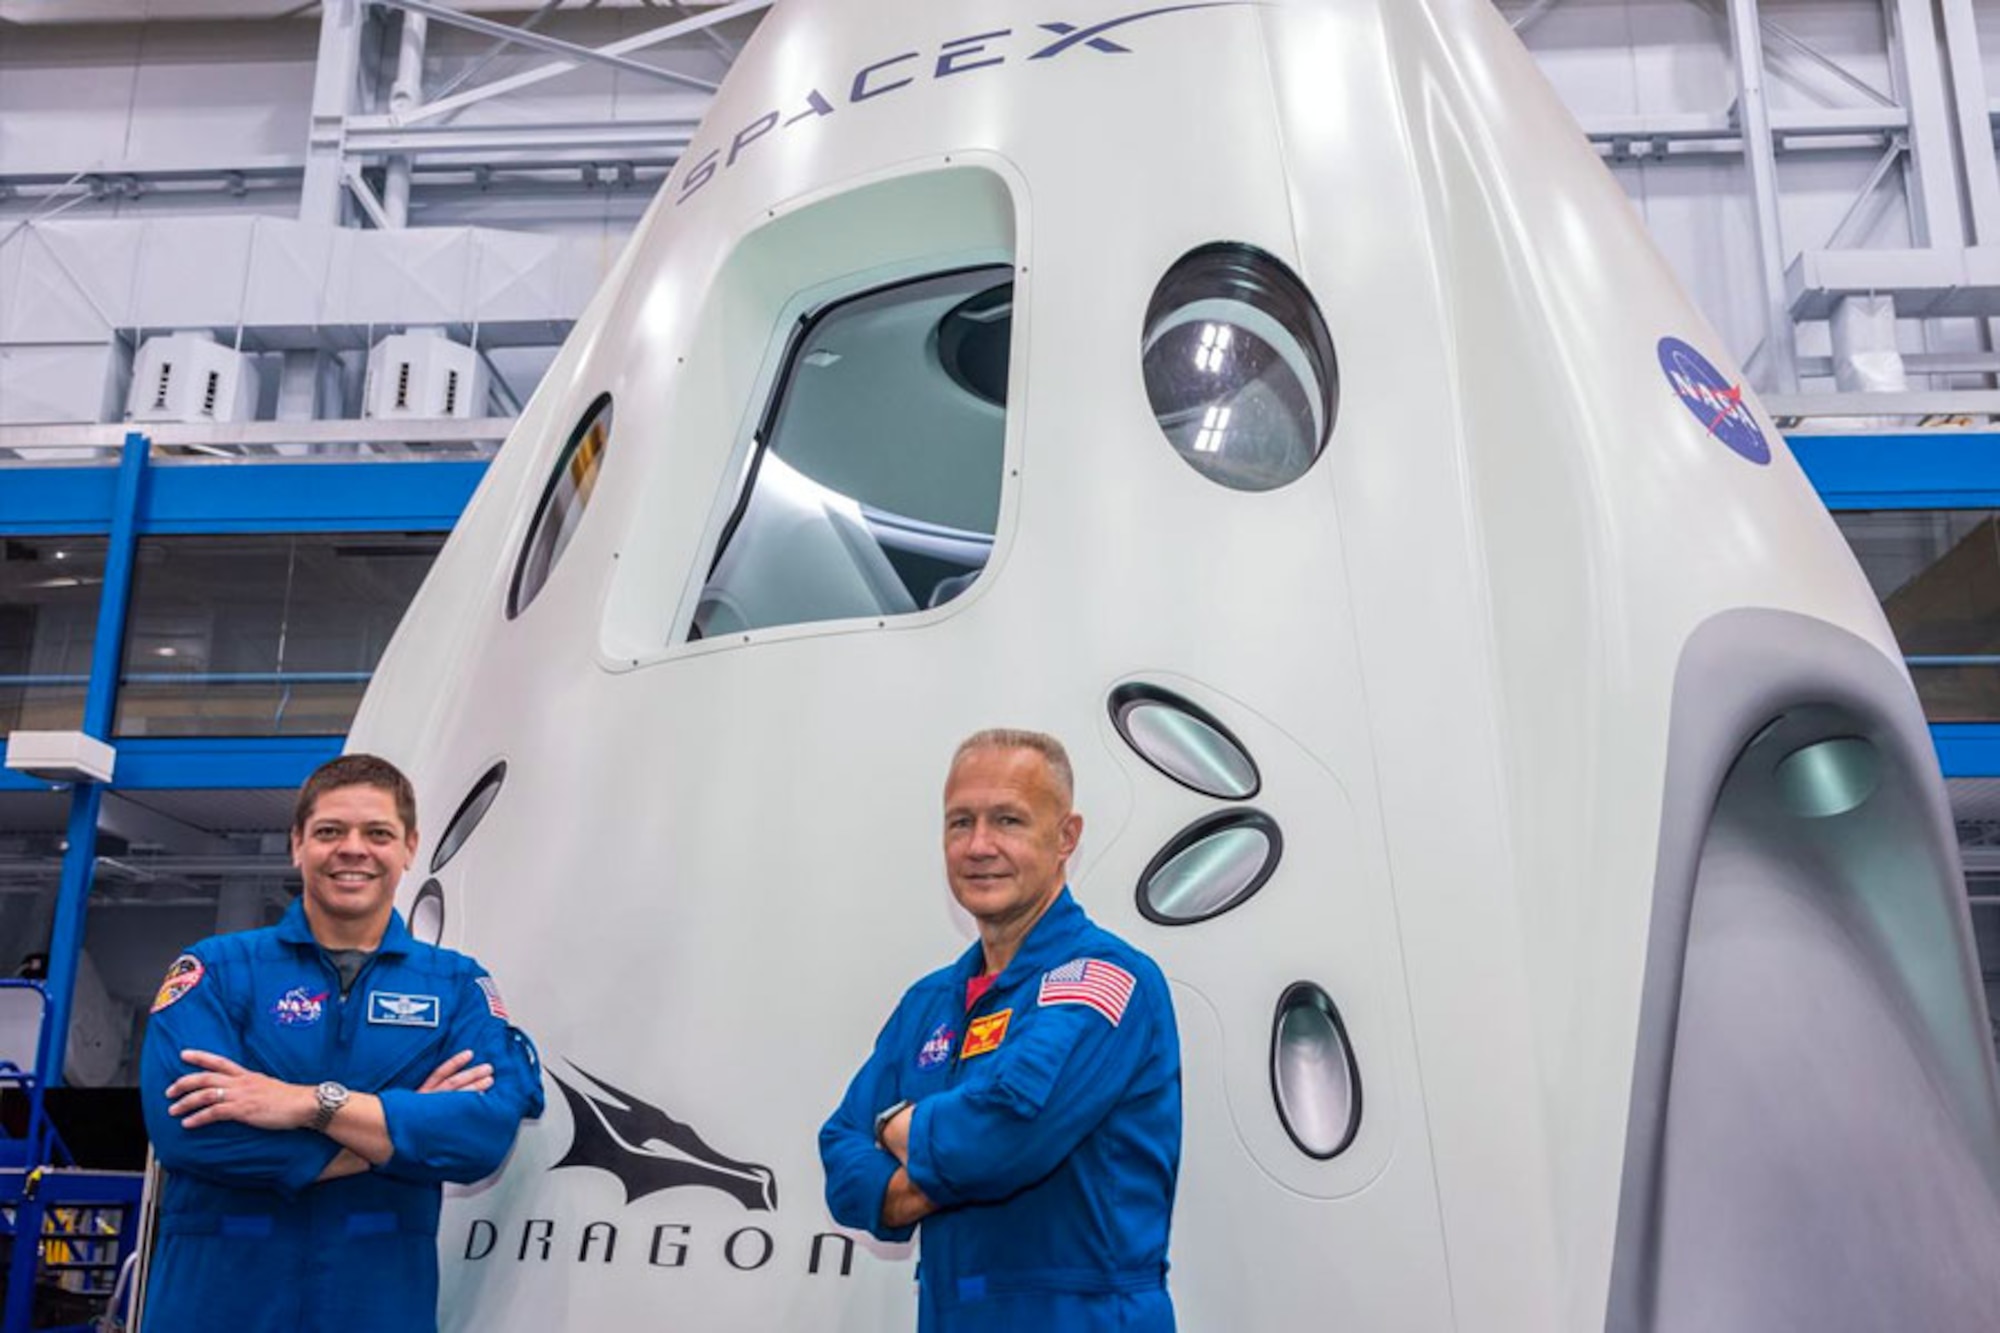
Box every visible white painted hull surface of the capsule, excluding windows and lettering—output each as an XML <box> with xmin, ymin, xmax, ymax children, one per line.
<box><xmin>352</xmin><ymin>0</ymin><xmax>1984</xmax><ymax>1333</ymax></box>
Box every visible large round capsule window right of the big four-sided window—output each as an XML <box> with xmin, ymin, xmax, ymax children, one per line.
<box><xmin>1140</xmin><ymin>244</ymin><xmax>1340</xmax><ymax>490</ymax></box>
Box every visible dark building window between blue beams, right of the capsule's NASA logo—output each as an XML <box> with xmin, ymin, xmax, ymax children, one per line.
<box><xmin>1834</xmin><ymin>508</ymin><xmax>2000</xmax><ymax>723</ymax></box>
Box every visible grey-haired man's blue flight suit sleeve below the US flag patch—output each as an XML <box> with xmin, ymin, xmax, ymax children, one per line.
<box><xmin>910</xmin><ymin>967</ymin><xmax>1170</xmax><ymax>1209</ymax></box>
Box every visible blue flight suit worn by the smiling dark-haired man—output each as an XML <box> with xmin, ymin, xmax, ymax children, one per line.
<box><xmin>140</xmin><ymin>903</ymin><xmax>542</xmax><ymax>1333</ymax></box>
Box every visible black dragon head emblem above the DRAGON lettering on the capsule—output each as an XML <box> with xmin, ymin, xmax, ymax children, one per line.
<box><xmin>548</xmin><ymin>1065</ymin><xmax>778</xmax><ymax>1213</ymax></box>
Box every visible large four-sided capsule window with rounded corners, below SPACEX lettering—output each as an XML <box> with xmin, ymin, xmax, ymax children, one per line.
<box><xmin>688</xmin><ymin>264</ymin><xmax>1014</xmax><ymax>638</ymax></box>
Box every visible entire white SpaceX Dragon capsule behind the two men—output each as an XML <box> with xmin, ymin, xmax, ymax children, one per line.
<box><xmin>352</xmin><ymin>0</ymin><xmax>2000</xmax><ymax>1333</ymax></box>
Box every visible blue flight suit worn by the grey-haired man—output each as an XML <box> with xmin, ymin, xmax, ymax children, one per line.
<box><xmin>820</xmin><ymin>889</ymin><xmax>1180</xmax><ymax>1333</ymax></box>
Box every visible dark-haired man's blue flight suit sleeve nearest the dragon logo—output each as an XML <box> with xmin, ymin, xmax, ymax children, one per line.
<box><xmin>376</xmin><ymin>973</ymin><xmax>542</xmax><ymax>1185</ymax></box>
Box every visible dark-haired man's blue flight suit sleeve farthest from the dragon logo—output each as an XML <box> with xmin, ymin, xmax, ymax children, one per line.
<box><xmin>138</xmin><ymin>953</ymin><xmax>340</xmax><ymax>1197</ymax></box>
